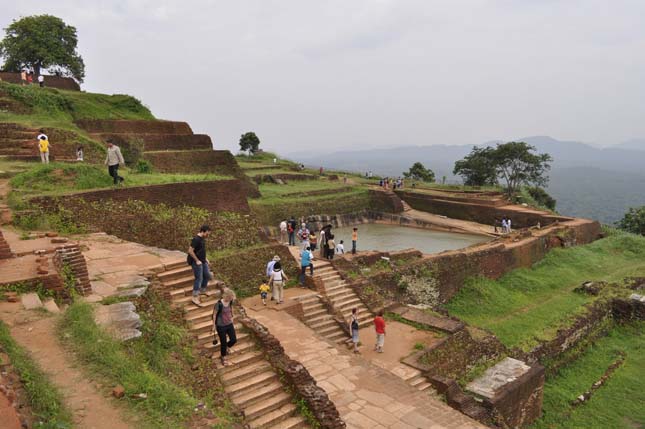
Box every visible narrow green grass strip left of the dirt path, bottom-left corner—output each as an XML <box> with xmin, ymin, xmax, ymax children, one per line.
<box><xmin>0</xmin><ymin>321</ymin><xmax>73</xmax><ymax>429</ymax></box>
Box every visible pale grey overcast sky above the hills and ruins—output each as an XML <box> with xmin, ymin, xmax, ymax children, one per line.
<box><xmin>0</xmin><ymin>0</ymin><xmax>645</xmax><ymax>153</ymax></box>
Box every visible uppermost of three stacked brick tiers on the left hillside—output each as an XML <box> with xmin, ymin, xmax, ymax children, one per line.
<box><xmin>76</xmin><ymin>119</ymin><xmax>193</xmax><ymax>134</ymax></box>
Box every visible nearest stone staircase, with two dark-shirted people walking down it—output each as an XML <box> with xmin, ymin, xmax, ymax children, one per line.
<box><xmin>158</xmin><ymin>261</ymin><xmax>309</xmax><ymax>429</ymax></box>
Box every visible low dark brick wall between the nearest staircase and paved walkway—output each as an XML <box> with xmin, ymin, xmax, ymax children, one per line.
<box><xmin>240</xmin><ymin>315</ymin><xmax>346</xmax><ymax>429</ymax></box>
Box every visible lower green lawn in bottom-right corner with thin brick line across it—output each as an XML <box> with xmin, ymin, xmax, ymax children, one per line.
<box><xmin>531</xmin><ymin>322</ymin><xmax>645</xmax><ymax>429</ymax></box>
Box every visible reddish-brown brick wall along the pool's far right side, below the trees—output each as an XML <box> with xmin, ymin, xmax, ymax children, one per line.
<box><xmin>396</xmin><ymin>191</ymin><xmax>571</xmax><ymax>228</ymax></box>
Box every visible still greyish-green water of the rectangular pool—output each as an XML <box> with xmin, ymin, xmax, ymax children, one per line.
<box><xmin>332</xmin><ymin>224</ymin><xmax>490</xmax><ymax>253</ymax></box>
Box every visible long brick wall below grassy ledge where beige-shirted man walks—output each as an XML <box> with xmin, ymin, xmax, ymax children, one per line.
<box><xmin>30</xmin><ymin>180</ymin><xmax>250</xmax><ymax>213</ymax></box>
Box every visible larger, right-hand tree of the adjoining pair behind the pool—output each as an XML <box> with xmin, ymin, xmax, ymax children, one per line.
<box><xmin>491</xmin><ymin>142</ymin><xmax>553</xmax><ymax>195</ymax></box>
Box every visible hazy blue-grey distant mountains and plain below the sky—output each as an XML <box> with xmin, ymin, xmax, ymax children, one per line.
<box><xmin>285</xmin><ymin>136</ymin><xmax>645</xmax><ymax>223</ymax></box>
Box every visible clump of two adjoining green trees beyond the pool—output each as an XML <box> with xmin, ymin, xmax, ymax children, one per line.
<box><xmin>453</xmin><ymin>142</ymin><xmax>553</xmax><ymax>196</ymax></box>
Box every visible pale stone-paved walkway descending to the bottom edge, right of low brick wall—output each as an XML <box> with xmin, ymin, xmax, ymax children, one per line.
<box><xmin>250</xmin><ymin>311</ymin><xmax>485</xmax><ymax>429</ymax></box>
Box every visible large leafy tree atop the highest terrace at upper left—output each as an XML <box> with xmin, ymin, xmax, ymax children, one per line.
<box><xmin>0</xmin><ymin>15</ymin><xmax>85</xmax><ymax>82</ymax></box>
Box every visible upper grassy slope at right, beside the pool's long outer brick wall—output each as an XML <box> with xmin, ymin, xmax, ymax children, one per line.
<box><xmin>447</xmin><ymin>233</ymin><xmax>645</xmax><ymax>350</ymax></box>
